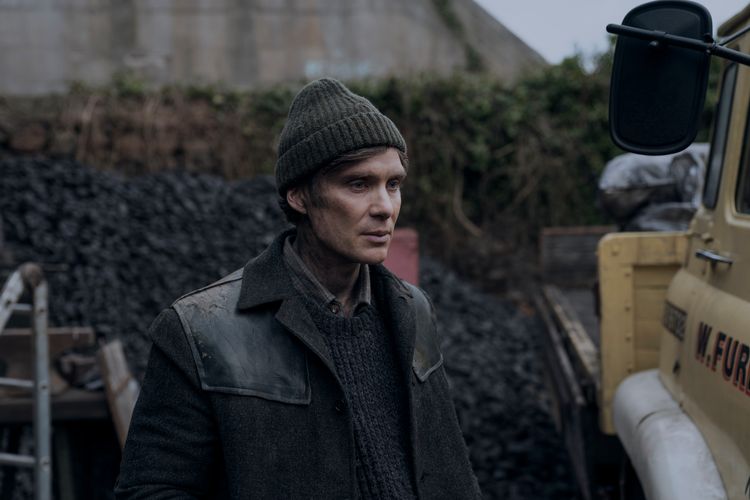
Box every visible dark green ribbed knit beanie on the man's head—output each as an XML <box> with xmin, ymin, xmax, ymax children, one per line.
<box><xmin>276</xmin><ymin>78</ymin><xmax>406</xmax><ymax>197</ymax></box>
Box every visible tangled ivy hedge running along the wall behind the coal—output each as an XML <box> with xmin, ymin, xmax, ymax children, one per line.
<box><xmin>0</xmin><ymin>53</ymin><xmax>718</xmax><ymax>286</ymax></box>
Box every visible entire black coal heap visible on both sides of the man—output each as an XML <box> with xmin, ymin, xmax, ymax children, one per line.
<box><xmin>0</xmin><ymin>158</ymin><xmax>575</xmax><ymax>499</ymax></box>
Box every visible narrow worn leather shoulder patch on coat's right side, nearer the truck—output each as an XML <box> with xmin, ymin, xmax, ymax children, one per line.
<box><xmin>402</xmin><ymin>282</ymin><xmax>443</xmax><ymax>382</ymax></box>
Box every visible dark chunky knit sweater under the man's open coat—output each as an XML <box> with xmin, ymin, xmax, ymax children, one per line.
<box><xmin>307</xmin><ymin>302</ymin><xmax>416</xmax><ymax>499</ymax></box>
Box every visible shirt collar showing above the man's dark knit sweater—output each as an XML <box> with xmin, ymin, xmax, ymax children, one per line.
<box><xmin>283</xmin><ymin>236</ymin><xmax>372</xmax><ymax>315</ymax></box>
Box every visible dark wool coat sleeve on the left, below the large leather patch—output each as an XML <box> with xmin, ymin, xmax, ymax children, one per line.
<box><xmin>115</xmin><ymin>309</ymin><xmax>223</xmax><ymax>499</ymax></box>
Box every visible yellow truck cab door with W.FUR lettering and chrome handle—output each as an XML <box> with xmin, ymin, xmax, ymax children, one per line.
<box><xmin>676</xmin><ymin>58</ymin><xmax>750</xmax><ymax>498</ymax></box>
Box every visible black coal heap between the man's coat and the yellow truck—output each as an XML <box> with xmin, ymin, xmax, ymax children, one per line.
<box><xmin>420</xmin><ymin>258</ymin><xmax>576</xmax><ymax>499</ymax></box>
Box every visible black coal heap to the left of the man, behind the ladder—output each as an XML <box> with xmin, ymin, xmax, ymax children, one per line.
<box><xmin>0</xmin><ymin>159</ymin><xmax>285</xmax><ymax>372</ymax></box>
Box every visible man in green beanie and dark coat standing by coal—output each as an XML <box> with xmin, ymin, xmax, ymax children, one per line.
<box><xmin>116</xmin><ymin>79</ymin><xmax>480</xmax><ymax>500</ymax></box>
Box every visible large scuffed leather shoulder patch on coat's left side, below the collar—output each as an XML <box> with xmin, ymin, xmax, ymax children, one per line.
<box><xmin>172</xmin><ymin>270</ymin><xmax>310</xmax><ymax>404</ymax></box>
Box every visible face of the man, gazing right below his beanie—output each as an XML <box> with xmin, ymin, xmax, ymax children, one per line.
<box><xmin>296</xmin><ymin>148</ymin><xmax>406</xmax><ymax>264</ymax></box>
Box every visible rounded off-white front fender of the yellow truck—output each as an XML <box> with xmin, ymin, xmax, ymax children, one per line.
<box><xmin>612</xmin><ymin>369</ymin><xmax>727</xmax><ymax>500</ymax></box>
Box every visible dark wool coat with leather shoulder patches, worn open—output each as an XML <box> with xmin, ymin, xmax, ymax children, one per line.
<box><xmin>115</xmin><ymin>235</ymin><xmax>481</xmax><ymax>500</ymax></box>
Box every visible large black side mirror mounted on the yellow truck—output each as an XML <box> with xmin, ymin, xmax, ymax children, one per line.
<box><xmin>609</xmin><ymin>0</ymin><xmax>712</xmax><ymax>155</ymax></box>
